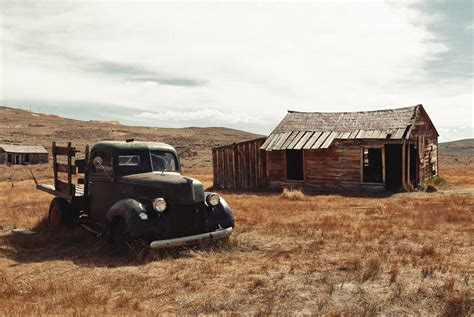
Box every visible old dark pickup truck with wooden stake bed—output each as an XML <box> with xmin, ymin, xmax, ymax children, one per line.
<box><xmin>36</xmin><ymin>140</ymin><xmax>234</xmax><ymax>249</ymax></box>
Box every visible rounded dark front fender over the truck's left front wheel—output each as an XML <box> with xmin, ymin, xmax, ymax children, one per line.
<box><xmin>106</xmin><ymin>198</ymin><xmax>147</xmax><ymax>236</ymax></box>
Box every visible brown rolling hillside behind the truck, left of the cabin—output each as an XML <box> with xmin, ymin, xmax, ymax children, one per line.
<box><xmin>0</xmin><ymin>107</ymin><xmax>259</xmax><ymax>170</ymax></box>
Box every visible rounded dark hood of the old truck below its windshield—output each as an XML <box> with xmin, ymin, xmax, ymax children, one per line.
<box><xmin>117</xmin><ymin>172</ymin><xmax>204</xmax><ymax>204</ymax></box>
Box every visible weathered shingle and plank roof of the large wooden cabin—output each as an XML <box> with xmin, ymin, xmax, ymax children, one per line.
<box><xmin>261</xmin><ymin>105</ymin><xmax>422</xmax><ymax>151</ymax></box>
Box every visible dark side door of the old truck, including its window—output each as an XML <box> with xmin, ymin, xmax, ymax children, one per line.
<box><xmin>88</xmin><ymin>149</ymin><xmax>120</xmax><ymax>223</ymax></box>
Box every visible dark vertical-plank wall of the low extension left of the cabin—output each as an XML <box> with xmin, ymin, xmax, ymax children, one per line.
<box><xmin>212</xmin><ymin>138</ymin><xmax>267</xmax><ymax>190</ymax></box>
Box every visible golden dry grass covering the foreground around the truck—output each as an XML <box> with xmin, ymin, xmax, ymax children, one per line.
<box><xmin>0</xmin><ymin>165</ymin><xmax>474</xmax><ymax>316</ymax></box>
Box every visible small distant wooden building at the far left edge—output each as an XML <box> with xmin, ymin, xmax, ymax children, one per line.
<box><xmin>0</xmin><ymin>144</ymin><xmax>48</xmax><ymax>165</ymax></box>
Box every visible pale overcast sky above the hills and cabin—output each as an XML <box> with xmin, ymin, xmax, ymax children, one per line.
<box><xmin>0</xmin><ymin>0</ymin><xmax>474</xmax><ymax>141</ymax></box>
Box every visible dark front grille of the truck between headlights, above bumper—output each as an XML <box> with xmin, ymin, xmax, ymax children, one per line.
<box><xmin>171</xmin><ymin>204</ymin><xmax>206</xmax><ymax>236</ymax></box>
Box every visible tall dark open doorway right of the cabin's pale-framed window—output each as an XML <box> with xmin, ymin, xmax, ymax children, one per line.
<box><xmin>385</xmin><ymin>144</ymin><xmax>402</xmax><ymax>189</ymax></box>
